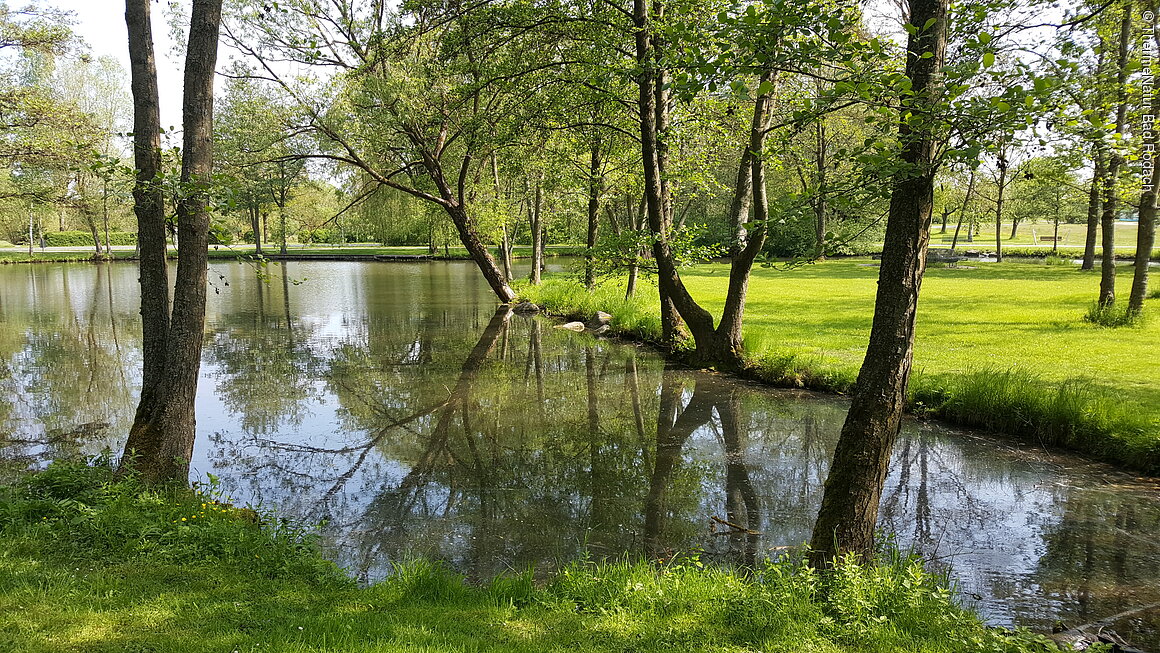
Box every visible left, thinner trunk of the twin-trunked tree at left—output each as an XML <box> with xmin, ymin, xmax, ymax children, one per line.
<box><xmin>122</xmin><ymin>0</ymin><xmax>169</xmax><ymax>467</ymax></box>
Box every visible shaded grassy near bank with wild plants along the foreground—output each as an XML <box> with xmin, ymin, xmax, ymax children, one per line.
<box><xmin>0</xmin><ymin>464</ymin><xmax>1052</xmax><ymax>653</ymax></box>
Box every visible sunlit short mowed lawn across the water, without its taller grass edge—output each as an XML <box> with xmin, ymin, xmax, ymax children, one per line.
<box><xmin>682</xmin><ymin>259</ymin><xmax>1160</xmax><ymax>414</ymax></box>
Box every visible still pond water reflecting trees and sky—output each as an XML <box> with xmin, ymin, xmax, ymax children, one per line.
<box><xmin>0</xmin><ymin>262</ymin><xmax>1160</xmax><ymax>647</ymax></box>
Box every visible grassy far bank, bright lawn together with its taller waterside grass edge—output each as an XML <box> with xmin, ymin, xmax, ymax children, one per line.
<box><xmin>521</xmin><ymin>259</ymin><xmax>1160</xmax><ymax>474</ymax></box>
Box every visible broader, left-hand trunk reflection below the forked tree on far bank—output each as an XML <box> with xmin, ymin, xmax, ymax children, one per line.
<box><xmin>645</xmin><ymin>371</ymin><xmax>713</xmax><ymax>556</ymax></box>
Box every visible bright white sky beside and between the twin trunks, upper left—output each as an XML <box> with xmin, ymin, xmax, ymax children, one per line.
<box><xmin>53</xmin><ymin>0</ymin><xmax>182</xmax><ymax>130</ymax></box>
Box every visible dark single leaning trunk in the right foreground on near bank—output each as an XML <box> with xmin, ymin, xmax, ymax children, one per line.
<box><xmin>810</xmin><ymin>0</ymin><xmax>947</xmax><ymax>567</ymax></box>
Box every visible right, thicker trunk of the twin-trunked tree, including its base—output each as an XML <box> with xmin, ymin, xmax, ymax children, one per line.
<box><xmin>125</xmin><ymin>0</ymin><xmax>222</xmax><ymax>483</ymax></box>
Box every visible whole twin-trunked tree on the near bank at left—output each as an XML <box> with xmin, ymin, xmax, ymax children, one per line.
<box><xmin>122</xmin><ymin>0</ymin><xmax>222</xmax><ymax>483</ymax></box>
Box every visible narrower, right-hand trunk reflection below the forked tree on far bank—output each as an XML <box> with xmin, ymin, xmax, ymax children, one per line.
<box><xmin>717</xmin><ymin>387</ymin><xmax>761</xmax><ymax>567</ymax></box>
